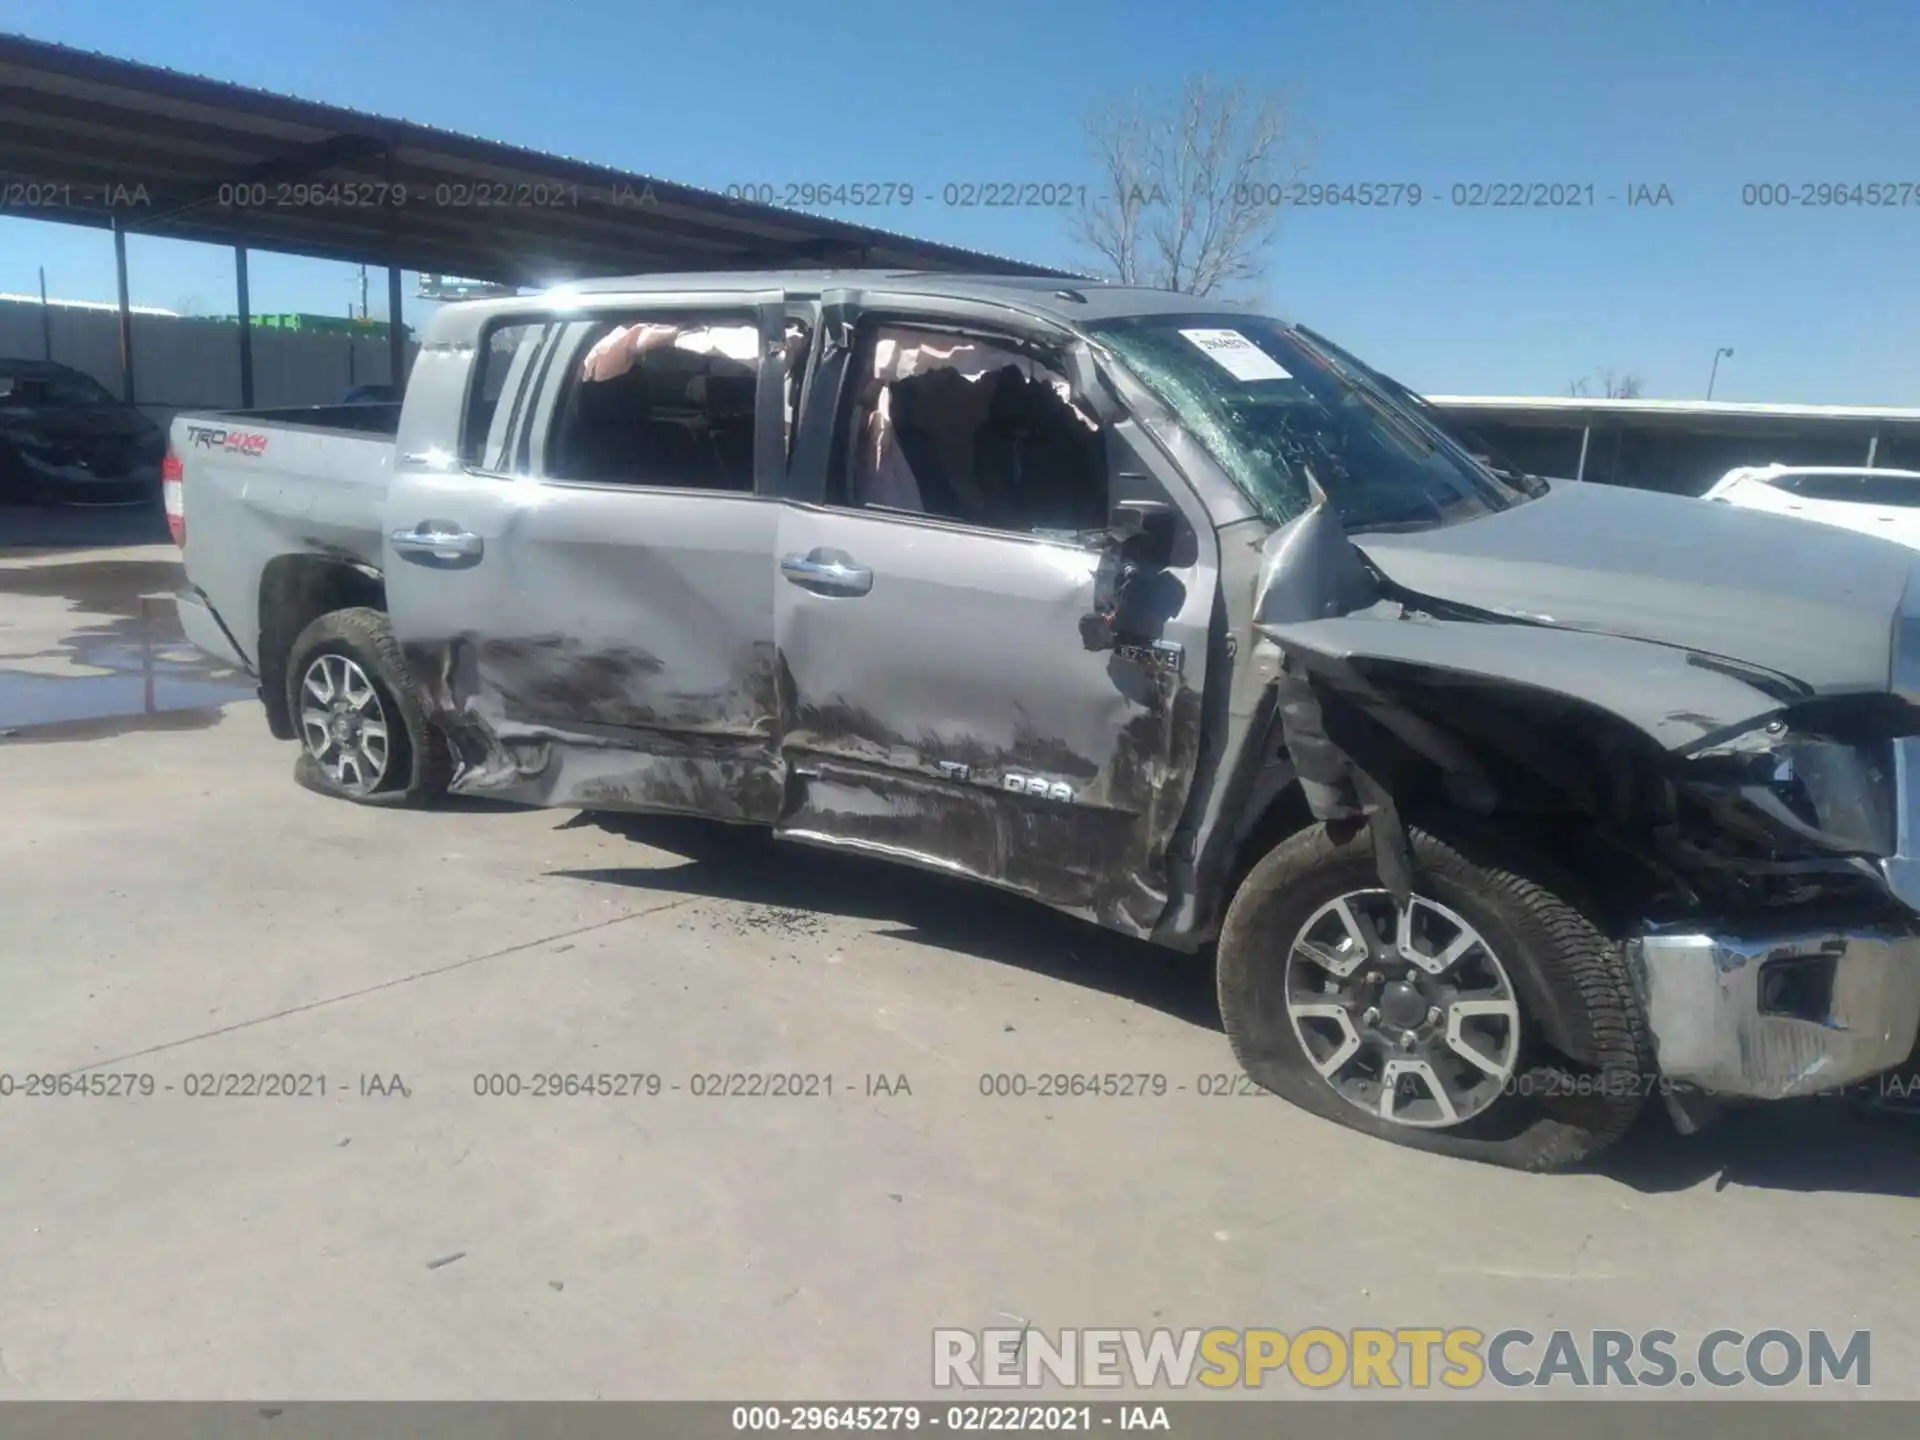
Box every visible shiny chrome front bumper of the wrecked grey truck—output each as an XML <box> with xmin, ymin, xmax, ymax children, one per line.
<box><xmin>1626</xmin><ymin>920</ymin><xmax>1920</xmax><ymax>1100</ymax></box>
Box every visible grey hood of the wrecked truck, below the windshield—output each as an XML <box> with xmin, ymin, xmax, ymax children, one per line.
<box><xmin>1352</xmin><ymin>484</ymin><xmax>1920</xmax><ymax>695</ymax></box>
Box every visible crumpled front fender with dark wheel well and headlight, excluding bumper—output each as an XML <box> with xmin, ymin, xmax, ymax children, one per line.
<box><xmin>1258</xmin><ymin>516</ymin><xmax>1920</xmax><ymax>914</ymax></box>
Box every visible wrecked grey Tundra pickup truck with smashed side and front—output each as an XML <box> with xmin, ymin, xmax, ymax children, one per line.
<box><xmin>169</xmin><ymin>273</ymin><xmax>1920</xmax><ymax>1169</ymax></box>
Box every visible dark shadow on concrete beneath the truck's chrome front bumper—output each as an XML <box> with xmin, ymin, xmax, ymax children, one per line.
<box><xmin>1594</xmin><ymin>1098</ymin><xmax>1920</xmax><ymax>1196</ymax></box>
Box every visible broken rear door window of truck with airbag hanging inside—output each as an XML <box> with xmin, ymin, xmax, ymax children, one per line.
<box><xmin>545</xmin><ymin>313</ymin><xmax>760</xmax><ymax>490</ymax></box>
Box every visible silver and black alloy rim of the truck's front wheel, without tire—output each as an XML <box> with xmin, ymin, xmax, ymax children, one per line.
<box><xmin>1284</xmin><ymin>889</ymin><xmax>1521</xmax><ymax>1129</ymax></box>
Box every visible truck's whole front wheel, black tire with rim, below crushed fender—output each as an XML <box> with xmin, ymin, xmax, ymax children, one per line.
<box><xmin>1219</xmin><ymin>826</ymin><xmax>1655</xmax><ymax>1169</ymax></box>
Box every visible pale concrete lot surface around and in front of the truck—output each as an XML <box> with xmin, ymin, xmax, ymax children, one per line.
<box><xmin>0</xmin><ymin>515</ymin><xmax>1920</xmax><ymax>1400</ymax></box>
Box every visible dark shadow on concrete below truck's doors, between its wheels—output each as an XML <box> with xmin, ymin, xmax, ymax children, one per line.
<box><xmin>549</xmin><ymin>812</ymin><xmax>1221</xmax><ymax>1031</ymax></box>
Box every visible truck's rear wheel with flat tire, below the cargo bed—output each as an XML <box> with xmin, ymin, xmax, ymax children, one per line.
<box><xmin>286</xmin><ymin>609</ymin><xmax>453</xmax><ymax>806</ymax></box>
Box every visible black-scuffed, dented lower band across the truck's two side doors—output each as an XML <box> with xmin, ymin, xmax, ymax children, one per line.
<box><xmin>409</xmin><ymin>602</ymin><xmax>1200</xmax><ymax>935</ymax></box>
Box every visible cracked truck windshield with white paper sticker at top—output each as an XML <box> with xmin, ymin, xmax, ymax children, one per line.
<box><xmin>1094</xmin><ymin>315</ymin><xmax>1526</xmax><ymax>532</ymax></box>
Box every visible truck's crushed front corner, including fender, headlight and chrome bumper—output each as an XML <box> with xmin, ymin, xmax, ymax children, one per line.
<box><xmin>1256</xmin><ymin>507</ymin><xmax>1920</xmax><ymax>1098</ymax></box>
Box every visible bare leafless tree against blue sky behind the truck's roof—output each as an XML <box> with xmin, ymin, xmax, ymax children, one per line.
<box><xmin>1073</xmin><ymin>77</ymin><xmax>1308</xmax><ymax>296</ymax></box>
